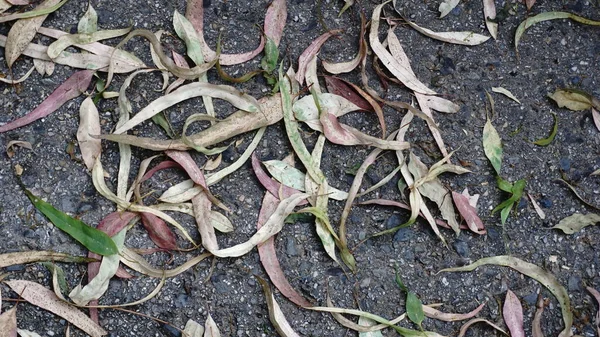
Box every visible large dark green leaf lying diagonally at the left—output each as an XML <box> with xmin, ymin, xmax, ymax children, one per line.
<box><xmin>24</xmin><ymin>189</ymin><xmax>119</xmax><ymax>255</ymax></box>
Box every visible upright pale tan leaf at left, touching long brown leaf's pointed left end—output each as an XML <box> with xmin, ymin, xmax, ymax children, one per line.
<box><xmin>77</xmin><ymin>96</ymin><xmax>102</xmax><ymax>171</ymax></box>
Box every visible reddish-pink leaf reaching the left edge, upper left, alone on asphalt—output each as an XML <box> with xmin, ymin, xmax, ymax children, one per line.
<box><xmin>0</xmin><ymin>70</ymin><xmax>94</xmax><ymax>133</ymax></box>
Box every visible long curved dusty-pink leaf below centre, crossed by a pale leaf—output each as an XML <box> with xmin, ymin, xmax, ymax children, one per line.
<box><xmin>256</xmin><ymin>192</ymin><xmax>312</xmax><ymax>307</ymax></box>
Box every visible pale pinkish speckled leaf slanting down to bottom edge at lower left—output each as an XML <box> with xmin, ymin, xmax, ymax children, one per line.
<box><xmin>5</xmin><ymin>280</ymin><xmax>108</xmax><ymax>337</ymax></box>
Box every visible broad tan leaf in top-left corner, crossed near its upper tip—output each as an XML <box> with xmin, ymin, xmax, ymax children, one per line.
<box><xmin>4</xmin><ymin>0</ymin><xmax>60</xmax><ymax>68</ymax></box>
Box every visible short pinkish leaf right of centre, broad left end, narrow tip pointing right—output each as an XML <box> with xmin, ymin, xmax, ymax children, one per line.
<box><xmin>319</xmin><ymin>112</ymin><xmax>410</xmax><ymax>150</ymax></box>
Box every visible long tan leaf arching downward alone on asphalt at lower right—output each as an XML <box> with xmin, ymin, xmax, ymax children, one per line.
<box><xmin>440</xmin><ymin>255</ymin><xmax>573</xmax><ymax>337</ymax></box>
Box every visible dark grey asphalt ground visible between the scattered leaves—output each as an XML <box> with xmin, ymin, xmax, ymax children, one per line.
<box><xmin>0</xmin><ymin>0</ymin><xmax>600</xmax><ymax>336</ymax></box>
